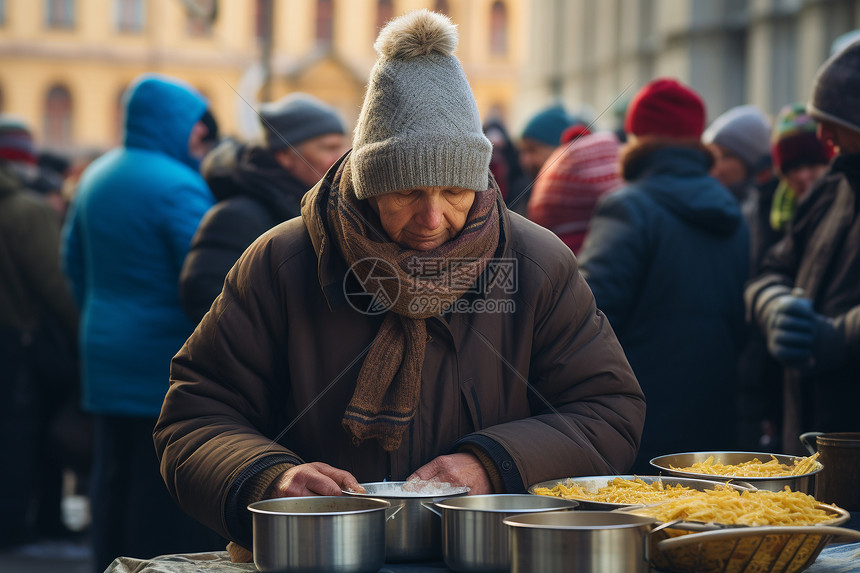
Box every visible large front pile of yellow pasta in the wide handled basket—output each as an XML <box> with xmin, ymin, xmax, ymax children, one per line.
<box><xmin>633</xmin><ymin>487</ymin><xmax>835</xmax><ymax>526</ymax></box>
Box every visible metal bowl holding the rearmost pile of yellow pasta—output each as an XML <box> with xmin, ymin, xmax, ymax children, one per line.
<box><xmin>651</xmin><ymin>452</ymin><xmax>822</xmax><ymax>495</ymax></box>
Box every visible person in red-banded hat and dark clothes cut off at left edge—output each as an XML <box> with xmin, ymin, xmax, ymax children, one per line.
<box><xmin>0</xmin><ymin>114</ymin><xmax>78</xmax><ymax>547</ymax></box>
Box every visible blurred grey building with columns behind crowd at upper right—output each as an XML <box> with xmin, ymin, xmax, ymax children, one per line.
<box><xmin>517</xmin><ymin>0</ymin><xmax>860</xmax><ymax>127</ymax></box>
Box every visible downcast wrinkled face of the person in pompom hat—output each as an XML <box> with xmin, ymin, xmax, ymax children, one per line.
<box><xmin>368</xmin><ymin>187</ymin><xmax>475</xmax><ymax>251</ymax></box>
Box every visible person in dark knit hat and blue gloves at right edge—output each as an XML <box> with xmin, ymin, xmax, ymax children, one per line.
<box><xmin>745</xmin><ymin>38</ymin><xmax>860</xmax><ymax>453</ymax></box>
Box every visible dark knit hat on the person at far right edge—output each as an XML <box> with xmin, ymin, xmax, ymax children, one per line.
<box><xmin>806</xmin><ymin>41</ymin><xmax>860</xmax><ymax>132</ymax></box>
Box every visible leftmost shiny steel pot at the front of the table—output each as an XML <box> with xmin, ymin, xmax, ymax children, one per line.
<box><xmin>248</xmin><ymin>496</ymin><xmax>396</xmax><ymax>573</ymax></box>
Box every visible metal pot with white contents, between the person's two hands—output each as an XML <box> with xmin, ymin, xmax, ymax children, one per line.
<box><xmin>344</xmin><ymin>481</ymin><xmax>469</xmax><ymax>562</ymax></box>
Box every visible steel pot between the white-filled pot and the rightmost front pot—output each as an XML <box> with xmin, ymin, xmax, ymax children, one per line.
<box><xmin>433</xmin><ymin>494</ymin><xmax>578</xmax><ymax>573</ymax></box>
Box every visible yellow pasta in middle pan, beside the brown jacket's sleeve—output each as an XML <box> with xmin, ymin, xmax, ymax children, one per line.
<box><xmin>534</xmin><ymin>478</ymin><xmax>694</xmax><ymax>504</ymax></box>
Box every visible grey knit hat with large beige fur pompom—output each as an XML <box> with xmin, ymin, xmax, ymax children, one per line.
<box><xmin>350</xmin><ymin>10</ymin><xmax>492</xmax><ymax>199</ymax></box>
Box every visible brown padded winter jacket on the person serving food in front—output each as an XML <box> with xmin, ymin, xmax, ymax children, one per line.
<box><xmin>155</xmin><ymin>166</ymin><xmax>645</xmax><ymax>547</ymax></box>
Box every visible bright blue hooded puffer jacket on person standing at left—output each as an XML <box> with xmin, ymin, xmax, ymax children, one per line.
<box><xmin>63</xmin><ymin>75</ymin><xmax>214</xmax><ymax>417</ymax></box>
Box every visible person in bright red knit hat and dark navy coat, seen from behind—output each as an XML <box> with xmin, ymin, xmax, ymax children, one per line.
<box><xmin>579</xmin><ymin>78</ymin><xmax>749</xmax><ymax>473</ymax></box>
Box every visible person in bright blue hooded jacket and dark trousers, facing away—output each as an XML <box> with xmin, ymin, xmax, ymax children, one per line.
<box><xmin>62</xmin><ymin>74</ymin><xmax>219</xmax><ymax>571</ymax></box>
